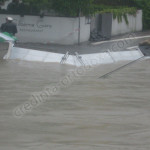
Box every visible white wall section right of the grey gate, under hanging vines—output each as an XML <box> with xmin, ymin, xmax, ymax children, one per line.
<box><xmin>112</xmin><ymin>10</ymin><xmax>143</xmax><ymax>36</ymax></box>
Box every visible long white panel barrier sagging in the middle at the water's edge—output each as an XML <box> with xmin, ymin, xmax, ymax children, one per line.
<box><xmin>5</xmin><ymin>47</ymin><xmax>143</xmax><ymax>66</ymax></box>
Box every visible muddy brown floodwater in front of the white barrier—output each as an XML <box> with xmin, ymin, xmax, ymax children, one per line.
<box><xmin>0</xmin><ymin>59</ymin><xmax>150</xmax><ymax>150</ymax></box>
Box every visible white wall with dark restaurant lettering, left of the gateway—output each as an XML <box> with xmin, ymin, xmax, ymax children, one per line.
<box><xmin>0</xmin><ymin>15</ymin><xmax>90</xmax><ymax>45</ymax></box>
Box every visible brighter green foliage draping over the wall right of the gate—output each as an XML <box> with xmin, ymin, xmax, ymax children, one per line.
<box><xmin>95</xmin><ymin>0</ymin><xmax>150</xmax><ymax>29</ymax></box>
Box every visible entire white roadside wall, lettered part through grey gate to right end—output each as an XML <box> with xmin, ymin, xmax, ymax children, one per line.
<box><xmin>0</xmin><ymin>10</ymin><xmax>142</xmax><ymax>45</ymax></box>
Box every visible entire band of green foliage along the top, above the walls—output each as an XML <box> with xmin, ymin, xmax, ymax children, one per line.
<box><xmin>0</xmin><ymin>0</ymin><xmax>150</xmax><ymax>29</ymax></box>
